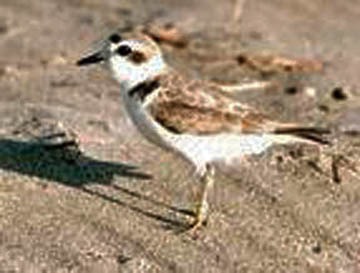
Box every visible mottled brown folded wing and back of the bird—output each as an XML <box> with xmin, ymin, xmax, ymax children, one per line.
<box><xmin>147</xmin><ymin>72</ymin><xmax>282</xmax><ymax>135</ymax></box>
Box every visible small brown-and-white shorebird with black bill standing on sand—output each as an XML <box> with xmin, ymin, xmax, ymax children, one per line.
<box><xmin>76</xmin><ymin>31</ymin><xmax>329</xmax><ymax>231</ymax></box>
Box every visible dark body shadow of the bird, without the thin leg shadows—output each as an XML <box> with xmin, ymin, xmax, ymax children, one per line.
<box><xmin>0</xmin><ymin>139</ymin><xmax>151</xmax><ymax>187</ymax></box>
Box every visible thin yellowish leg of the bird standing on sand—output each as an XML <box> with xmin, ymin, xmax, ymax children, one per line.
<box><xmin>190</xmin><ymin>165</ymin><xmax>214</xmax><ymax>232</ymax></box>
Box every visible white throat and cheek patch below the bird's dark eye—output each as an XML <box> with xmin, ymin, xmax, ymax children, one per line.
<box><xmin>109</xmin><ymin>54</ymin><xmax>166</xmax><ymax>90</ymax></box>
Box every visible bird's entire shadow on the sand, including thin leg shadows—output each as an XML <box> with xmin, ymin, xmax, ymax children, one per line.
<box><xmin>0</xmin><ymin>139</ymin><xmax>191</xmax><ymax>228</ymax></box>
